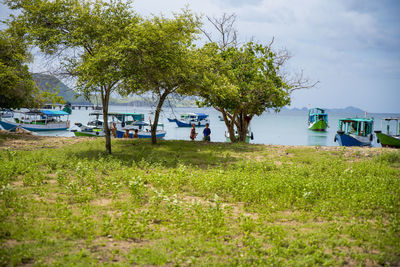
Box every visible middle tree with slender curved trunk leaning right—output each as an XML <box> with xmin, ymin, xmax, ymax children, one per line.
<box><xmin>125</xmin><ymin>10</ymin><xmax>199</xmax><ymax>144</ymax></box>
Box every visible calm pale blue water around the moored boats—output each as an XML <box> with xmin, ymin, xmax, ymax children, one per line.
<box><xmin>39</xmin><ymin>106</ymin><xmax>400</xmax><ymax>149</ymax></box>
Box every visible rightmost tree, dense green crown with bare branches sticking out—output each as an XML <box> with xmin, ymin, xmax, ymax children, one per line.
<box><xmin>199</xmin><ymin>14</ymin><xmax>315</xmax><ymax>142</ymax></box>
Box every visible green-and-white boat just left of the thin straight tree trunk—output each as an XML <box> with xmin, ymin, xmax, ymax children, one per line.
<box><xmin>70</xmin><ymin>111</ymin><xmax>105</xmax><ymax>137</ymax></box>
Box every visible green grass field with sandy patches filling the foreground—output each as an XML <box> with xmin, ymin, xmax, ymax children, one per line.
<box><xmin>0</xmin><ymin>134</ymin><xmax>400</xmax><ymax>266</ymax></box>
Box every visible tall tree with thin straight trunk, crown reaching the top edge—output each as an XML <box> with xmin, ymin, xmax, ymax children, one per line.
<box><xmin>7</xmin><ymin>0</ymin><xmax>140</xmax><ymax>153</ymax></box>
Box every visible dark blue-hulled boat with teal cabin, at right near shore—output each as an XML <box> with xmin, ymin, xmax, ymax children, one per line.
<box><xmin>334</xmin><ymin>118</ymin><xmax>374</xmax><ymax>146</ymax></box>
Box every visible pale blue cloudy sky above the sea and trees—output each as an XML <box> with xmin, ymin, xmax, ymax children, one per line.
<box><xmin>0</xmin><ymin>0</ymin><xmax>400</xmax><ymax>113</ymax></box>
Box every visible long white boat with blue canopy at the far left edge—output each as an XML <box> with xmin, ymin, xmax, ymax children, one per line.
<box><xmin>0</xmin><ymin>109</ymin><xmax>70</xmax><ymax>132</ymax></box>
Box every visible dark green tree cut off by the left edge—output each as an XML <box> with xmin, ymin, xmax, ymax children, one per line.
<box><xmin>0</xmin><ymin>31</ymin><xmax>41</xmax><ymax>108</ymax></box>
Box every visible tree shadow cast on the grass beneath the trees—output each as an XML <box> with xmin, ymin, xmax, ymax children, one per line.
<box><xmin>68</xmin><ymin>139</ymin><xmax>260</xmax><ymax>169</ymax></box>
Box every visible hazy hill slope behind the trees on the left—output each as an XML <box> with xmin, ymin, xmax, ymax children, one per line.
<box><xmin>32</xmin><ymin>73</ymin><xmax>91</xmax><ymax>105</ymax></box>
